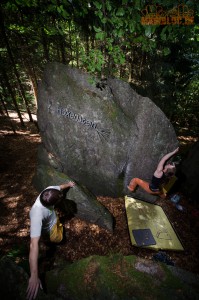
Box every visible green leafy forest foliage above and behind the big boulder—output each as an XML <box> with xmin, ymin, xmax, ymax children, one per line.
<box><xmin>0</xmin><ymin>0</ymin><xmax>199</xmax><ymax>132</ymax></box>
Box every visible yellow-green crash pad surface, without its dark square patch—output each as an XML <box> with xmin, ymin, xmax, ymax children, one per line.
<box><xmin>125</xmin><ymin>196</ymin><xmax>184</xmax><ymax>251</ymax></box>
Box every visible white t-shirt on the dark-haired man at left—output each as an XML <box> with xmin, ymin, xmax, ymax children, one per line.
<box><xmin>30</xmin><ymin>186</ymin><xmax>60</xmax><ymax>238</ymax></box>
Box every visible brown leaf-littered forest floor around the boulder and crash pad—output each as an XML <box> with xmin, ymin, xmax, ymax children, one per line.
<box><xmin>0</xmin><ymin>114</ymin><xmax>199</xmax><ymax>273</ymax></box>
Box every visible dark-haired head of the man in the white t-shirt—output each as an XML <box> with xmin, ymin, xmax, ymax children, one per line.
<box><xmin>40</xmin><ymin>189</ymin><xmax>62</xmax><ymax>207</ymax></box>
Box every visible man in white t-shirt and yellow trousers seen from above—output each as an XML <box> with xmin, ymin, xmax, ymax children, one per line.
<box><xmin>27</xmin><ymin>181</ymin><xmax>75</xmax><ymax>300</ymax></box>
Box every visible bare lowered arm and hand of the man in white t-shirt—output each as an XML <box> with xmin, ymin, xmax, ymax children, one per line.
<box><xmin>27</xmin><ymin>237</ymin><xmax>42</xmax><ymax>300</ymax></box>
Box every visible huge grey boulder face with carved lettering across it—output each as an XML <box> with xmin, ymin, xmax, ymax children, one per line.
<box><xmin>38</xmin><ymin>63</ymin><xmax>178</xmax><ymax>197</ymax></box>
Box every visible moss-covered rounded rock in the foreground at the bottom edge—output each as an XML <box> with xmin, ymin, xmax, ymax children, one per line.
<box><xmin>46</xmin><ymin>255</ymin><xmax>199</xmax><ymax>300</ymax></box>
